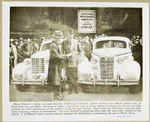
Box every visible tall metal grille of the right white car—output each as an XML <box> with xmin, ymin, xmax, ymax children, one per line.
<box><xmin>100</xmin><ymin>57</ymin><xmax>114</xmax><ymax>79</ymax></box>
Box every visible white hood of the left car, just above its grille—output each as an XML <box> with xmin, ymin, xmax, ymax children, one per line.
<box><xmin>31</xmin><ymin>50</ymin><xmax>50</xmax><ymax>58</ymax></box>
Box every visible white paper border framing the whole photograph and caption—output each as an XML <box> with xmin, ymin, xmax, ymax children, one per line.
<box><xmin>2</xmin><ymin>2</ymin><xmax>149</xmax><ymax>121</ymax></box>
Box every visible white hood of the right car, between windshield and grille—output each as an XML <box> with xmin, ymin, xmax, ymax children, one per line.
<box><xmin>93</xmin><ymin>48</ymin><xmax>131</xmax><ymax>57</ymax></box>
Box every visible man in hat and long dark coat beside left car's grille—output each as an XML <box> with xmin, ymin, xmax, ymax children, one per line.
<box><xmin>47</xmin><ymin>31</ymin><xmax>63</xmax><ymax>100</ymax></box>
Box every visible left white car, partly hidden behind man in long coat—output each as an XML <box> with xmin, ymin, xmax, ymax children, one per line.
<box><xmin>11</xmin><ymin>39</ymin><xmax>63</xmax><ymax>92</ymax></box>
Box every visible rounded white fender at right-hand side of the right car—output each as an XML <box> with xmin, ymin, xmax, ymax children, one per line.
<box><xmin>120</xmin><ymin>61</ymin><xmax>141</xmax><ymax>81</ymax></box>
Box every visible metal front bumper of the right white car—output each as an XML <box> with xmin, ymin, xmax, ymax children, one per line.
<box><xmin>77</xmin><ymin>80</ymin><xmax>139</xmax><ymax>86</ymax></box>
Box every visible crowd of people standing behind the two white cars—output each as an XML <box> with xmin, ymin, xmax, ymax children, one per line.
<box><xmin>9</xmin><ymin>34</ymin><xmax>142</xmax><ymax>71</ymax></box>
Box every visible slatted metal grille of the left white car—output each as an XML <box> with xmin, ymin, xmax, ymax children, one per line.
<box><xmin>32</xmin><ymin>58</ymin><xmax>44</xmax><ymax>73</ymax></box>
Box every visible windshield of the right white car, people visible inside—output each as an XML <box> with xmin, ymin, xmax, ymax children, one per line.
<box><xmin>96</xmin><ymin>40</ymin><xmax>126</xmax><ymax>49</ymax></box>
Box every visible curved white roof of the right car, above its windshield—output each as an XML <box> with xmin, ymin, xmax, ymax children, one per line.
<box><xmin>94</xmin><ymin>36</ymin><xmax>130</xmax><ymax>42</ymax></box>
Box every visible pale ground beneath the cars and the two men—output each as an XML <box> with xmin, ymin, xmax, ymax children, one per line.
<box><xmin>10</xmin><ymin>78</ymin><xmax>142</xmax><ymax>102</ymax></box>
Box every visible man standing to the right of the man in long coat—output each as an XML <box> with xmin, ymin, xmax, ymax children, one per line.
<box><xmin>62</xmin><ymin>29</ymin><xmax>81</xmax><ymax>94</ymax></box>
